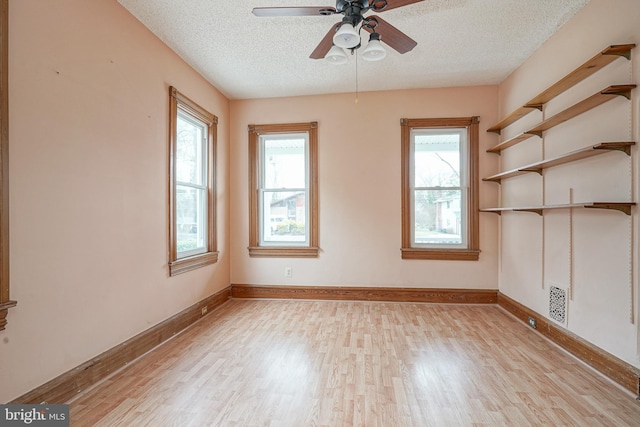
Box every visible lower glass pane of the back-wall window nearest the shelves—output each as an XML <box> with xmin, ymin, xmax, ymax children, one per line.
<box><xmin>413</xmin><ymin>189</ymin><xmax>463</xmax><ymax>245</ymax></box>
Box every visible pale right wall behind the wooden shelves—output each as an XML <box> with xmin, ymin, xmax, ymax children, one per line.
<box><xmin>500</xmin><ymin>0</ymin><xmax>640</xmax><ymax>366</ymax></box>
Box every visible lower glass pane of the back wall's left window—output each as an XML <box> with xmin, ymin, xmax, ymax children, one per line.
<box><xmin>262</xmin><ymin>191</ymin><xmax>307</xmax><ymax>244</ymax></box>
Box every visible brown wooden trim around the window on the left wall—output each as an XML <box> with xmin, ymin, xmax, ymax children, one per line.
<box><xmin>169</xmin><ymin>87</ymin><xmax>218</xmax><ymax>276</ymax></box>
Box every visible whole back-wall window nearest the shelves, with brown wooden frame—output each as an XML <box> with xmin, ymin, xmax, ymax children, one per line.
<box><xmin>401</xmin><ymin>117</ymin><xmax>480</xmax><ymax>261</ymax></box>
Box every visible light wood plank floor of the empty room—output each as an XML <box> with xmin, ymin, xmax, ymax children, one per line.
<box><xmin>71</xmin><ymin>300</ymin><xmax>640</xmax><ymax>427</ymax></box>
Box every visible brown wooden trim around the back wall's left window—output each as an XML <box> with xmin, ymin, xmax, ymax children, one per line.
<box><xmin>248</xmin><ymin>122</ymin><xmax>320</xmax><ymax>258</ymax></box>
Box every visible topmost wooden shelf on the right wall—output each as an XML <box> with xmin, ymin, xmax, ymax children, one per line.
<box><xmin>487</xmin><ymin>44</ymin><xmax>636</xmax><ymax>134</ymax></box>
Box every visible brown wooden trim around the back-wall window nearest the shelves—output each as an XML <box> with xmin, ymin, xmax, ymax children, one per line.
<box><xmin>400</xmin><ymin>116</ymin><xmax>480</xmax><ymax>261</ymax></box>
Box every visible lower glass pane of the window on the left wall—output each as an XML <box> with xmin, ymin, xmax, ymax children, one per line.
<box><xmin>176</xmin><ymin>185</ymin><xmax>207</xmax><ymax>256</ymax></box>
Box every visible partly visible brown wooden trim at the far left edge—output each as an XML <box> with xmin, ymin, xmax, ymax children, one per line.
<box><xmin>0</xmin><ymin>0</ymin><xmax>17</xmax><ymax>331</ymax></box>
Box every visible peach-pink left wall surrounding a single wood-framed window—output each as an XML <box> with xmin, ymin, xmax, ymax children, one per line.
<box><xmin>0</xmin><ymin>0</ymin><xmax>230</xmax><ymax>402</ymax></box>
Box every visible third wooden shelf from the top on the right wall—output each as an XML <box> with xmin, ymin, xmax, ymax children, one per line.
<box><xmin>482</xmin><ymin>141</ymin><xmax>635</xmax><ymax>184</ymax></box>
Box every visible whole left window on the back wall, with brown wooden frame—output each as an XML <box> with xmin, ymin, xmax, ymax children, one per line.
<box><xmin>249</xmin><ymin>122</ymin><xmax>319</xmax><ymax>257</ymax></box>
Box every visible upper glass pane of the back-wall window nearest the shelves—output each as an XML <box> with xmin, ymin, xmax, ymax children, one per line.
<box><xmin>414</xmin><ymin>132</ymin><xmax>460</xmax><ymax>188</ymax></box>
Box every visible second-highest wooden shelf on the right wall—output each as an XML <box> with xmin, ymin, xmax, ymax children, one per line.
<box><xmin>487</xmin><ymin>84</ymin><xmax>636</xmax><ymax>154</ymax></box>
